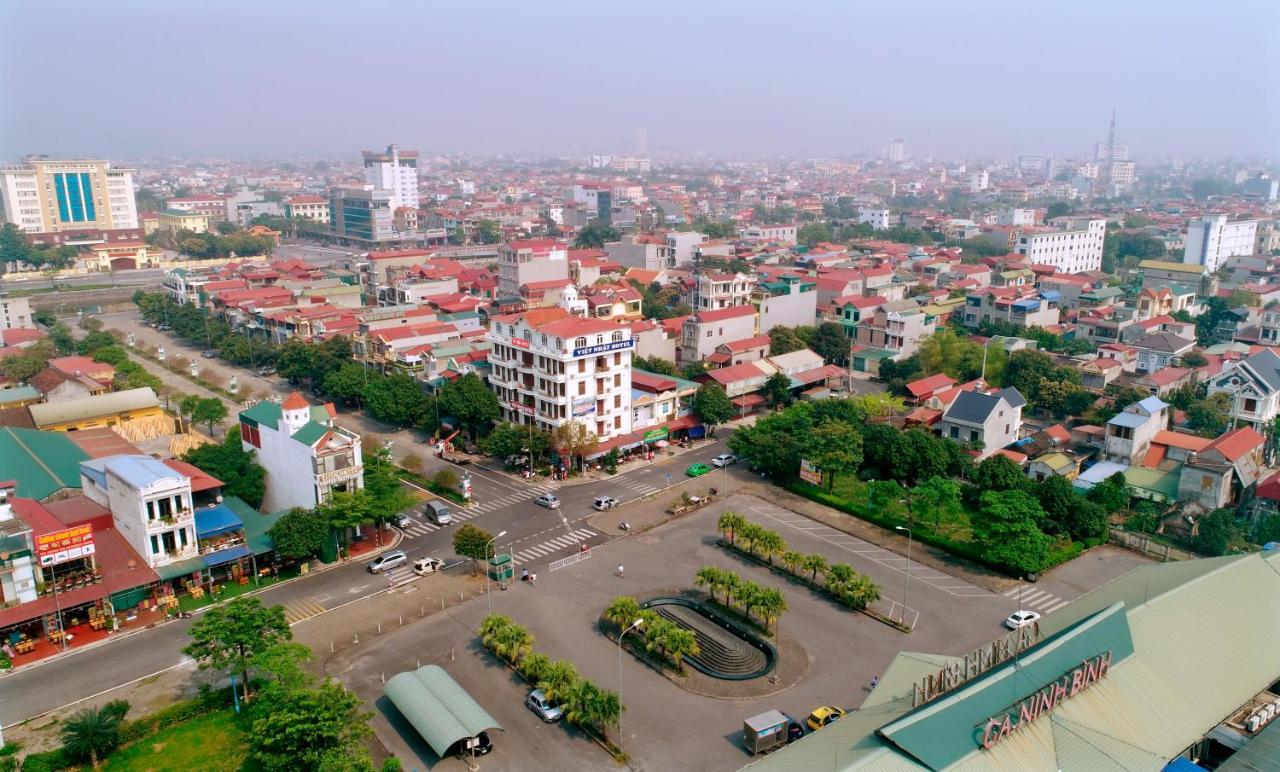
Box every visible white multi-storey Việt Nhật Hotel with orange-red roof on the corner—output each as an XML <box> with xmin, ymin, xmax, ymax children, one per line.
<box><xmin>486</xmin><ymin>309</ymin><xmax>635</xmax><ymax>440</ymax></box>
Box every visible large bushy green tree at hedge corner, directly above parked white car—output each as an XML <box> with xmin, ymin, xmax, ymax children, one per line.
<box><xmin>973</xmin><ymin>490</ymin><xmax>1050</xmax><ymax>574</ymax></box>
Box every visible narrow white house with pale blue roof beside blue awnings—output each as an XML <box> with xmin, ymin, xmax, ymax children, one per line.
<box><xmin>79</xmin><ymin>456</ymin><xmax>200</xmax><ymax>568</ymax></box>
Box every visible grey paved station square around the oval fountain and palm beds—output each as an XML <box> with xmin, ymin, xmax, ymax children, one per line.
<box><xmin>329</xmin><ymin>495</ymin><xmax>1152</xmax><ymax>771</ymax></box>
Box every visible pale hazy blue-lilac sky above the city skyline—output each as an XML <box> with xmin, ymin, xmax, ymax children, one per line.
<box><xmin>0</xmin><ymin>0</ymin><xmax>1280</xmax><ymax>159</ymax></box>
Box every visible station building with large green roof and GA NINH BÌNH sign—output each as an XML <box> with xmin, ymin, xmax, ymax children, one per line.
<box><xmin>749</xmin><ymin>552</ymin><xmax>1280</xmax><ymax>772</ymax></box>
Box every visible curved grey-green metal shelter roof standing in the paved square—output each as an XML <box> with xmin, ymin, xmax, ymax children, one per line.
<box><xmin>385</xmin><ymin>664</ymin><xmax>502</xmax><ymax>757</ymax></box>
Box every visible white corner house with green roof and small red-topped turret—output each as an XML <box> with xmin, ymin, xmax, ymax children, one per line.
<box><xmin>239</xmin><ymin>392</ymin><xmax>365</xmax><ymax>512</ymax></box>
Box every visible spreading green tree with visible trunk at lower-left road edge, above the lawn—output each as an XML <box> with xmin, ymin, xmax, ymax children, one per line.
<box><xmin>182</xmin><ymin>597</ymin><xmax>293</xmax><ymax>700</ymax></box>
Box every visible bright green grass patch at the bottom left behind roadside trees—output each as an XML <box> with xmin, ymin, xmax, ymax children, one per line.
<box><xmin>102</xmin><ymin>708</ymin><xmax>248</xmax><ymax>772</ymax></box>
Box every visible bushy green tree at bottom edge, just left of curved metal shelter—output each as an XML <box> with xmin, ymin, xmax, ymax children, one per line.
<box><xmin>250</xmin><ymin>681</ymin><xmax>372</xmax><ymax>772</ymax></box>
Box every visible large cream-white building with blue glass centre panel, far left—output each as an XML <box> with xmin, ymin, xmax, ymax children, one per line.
<box><xmin>0</xmin><ymin>157</ymin><xmax>138</xmax><ymax>233</ymax></box>
